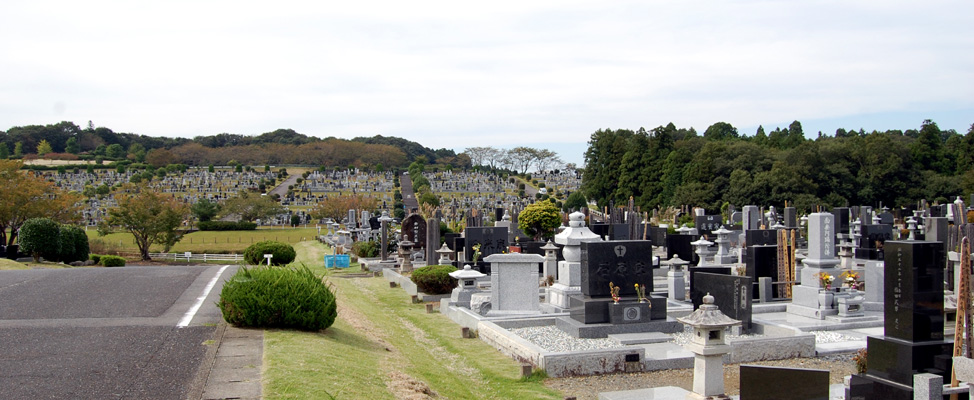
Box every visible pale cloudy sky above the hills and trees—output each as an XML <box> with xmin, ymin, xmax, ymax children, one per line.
<box><xmin>0</xmin><ymin>0</ymin><xmax>974</xmax><ymax>164</ymax></box>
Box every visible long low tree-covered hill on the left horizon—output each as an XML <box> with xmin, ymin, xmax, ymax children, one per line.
<box><xmin>0</xmin><ymin>121</ymin><xmax>470</xmax><ymax>168</ymax></box>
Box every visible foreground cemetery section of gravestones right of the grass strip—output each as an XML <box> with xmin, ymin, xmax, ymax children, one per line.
<box><xmin>334</xmin><ymin>189</ymin><xmax>974</xmax><ymax>399</ymax></box>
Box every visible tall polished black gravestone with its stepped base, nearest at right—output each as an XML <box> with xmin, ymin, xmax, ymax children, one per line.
<box><xmin>850</xmin><ymin>240</ymin><xmax>953</xmax><ymax>399</ymax></box>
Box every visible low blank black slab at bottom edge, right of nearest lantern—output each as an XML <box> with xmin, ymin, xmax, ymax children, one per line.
<box><xmin>741</xmin><ymin>365</ymin><xmax>829</xmax><ymax>400</ymax></box>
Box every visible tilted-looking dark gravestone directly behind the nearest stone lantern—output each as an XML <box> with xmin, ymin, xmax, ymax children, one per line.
<box><xmin>690</xmin><ymin>267</ymin><xmax>754</xmax><ymax>332</ymax></box>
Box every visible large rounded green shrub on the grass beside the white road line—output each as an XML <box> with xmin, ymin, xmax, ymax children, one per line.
<box><xmin>218</xmin><ymin>265</ymin><xmax>338</xmax><ymax>331</ymax></box>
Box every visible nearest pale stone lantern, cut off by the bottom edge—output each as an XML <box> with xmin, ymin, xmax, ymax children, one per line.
<box><xmin>677</xmin><ymin>293</ymin><xmax>741</xmax><ymax>400</ymax></box>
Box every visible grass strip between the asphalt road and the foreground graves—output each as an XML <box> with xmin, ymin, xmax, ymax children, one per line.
<box><xmin>263</xmin><ymin>242</ymin><xmax>562</xmax><ymax>399</ymax></box>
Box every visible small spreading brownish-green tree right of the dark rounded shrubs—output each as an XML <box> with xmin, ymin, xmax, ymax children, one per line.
<box><xmin>98</xmin><ymin>185</ymin><xmax>189</xmax><ymax>260</ymax></box>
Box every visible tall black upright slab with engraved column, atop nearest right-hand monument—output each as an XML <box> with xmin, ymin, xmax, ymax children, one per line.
<box><xmin>884</xmin><ymin>240</ymin><xmax>946</xmax><ymax>342</ymax></box>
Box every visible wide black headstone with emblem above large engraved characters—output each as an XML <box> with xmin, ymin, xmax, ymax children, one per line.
<box><xmin>581</xmin><ymin>240</ymin><xmax>653</xmax><ymax>297</ymax></box>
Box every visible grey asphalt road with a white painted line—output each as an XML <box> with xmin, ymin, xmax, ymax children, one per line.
<box><xmin>0</xmin><ymin>266</ymin><xmax>235</xmax><ymax>399</ymax></box>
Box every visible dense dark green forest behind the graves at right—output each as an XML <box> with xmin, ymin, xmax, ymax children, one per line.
<box><xmin>582</xmin><ymin>120</ymin><xmax>974</xmax><ymax>213</ymax></box>
